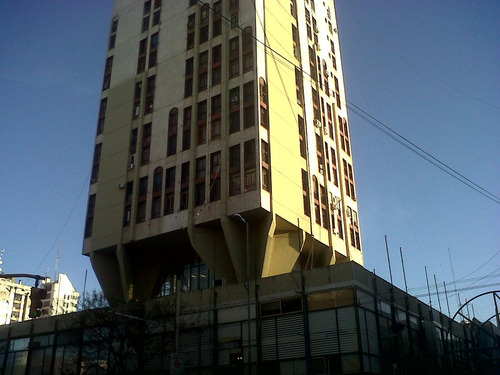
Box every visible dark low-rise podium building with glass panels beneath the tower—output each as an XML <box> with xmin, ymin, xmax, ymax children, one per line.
<box><xmin>0</xmin><ymin>262</ymin><xmax>500</xmax><ymax>375</ymax></box>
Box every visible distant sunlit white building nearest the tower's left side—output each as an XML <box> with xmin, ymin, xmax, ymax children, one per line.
<box><xmin>42</xmin><ymin>273</ymin><xmax>80</xmax><ymax>317</ymax></box>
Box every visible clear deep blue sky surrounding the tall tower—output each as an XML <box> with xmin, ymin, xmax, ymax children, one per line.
<box><xmin>0</xmin><ymin>0</ymin><xmax>500</xmax><ymax>318</ymax></box>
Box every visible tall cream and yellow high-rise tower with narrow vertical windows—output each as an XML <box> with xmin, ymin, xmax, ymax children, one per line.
<box><xmin>83</xmin><ymin>0</ymin><xmax>363</xmax><ymax>301</ymax></box>
